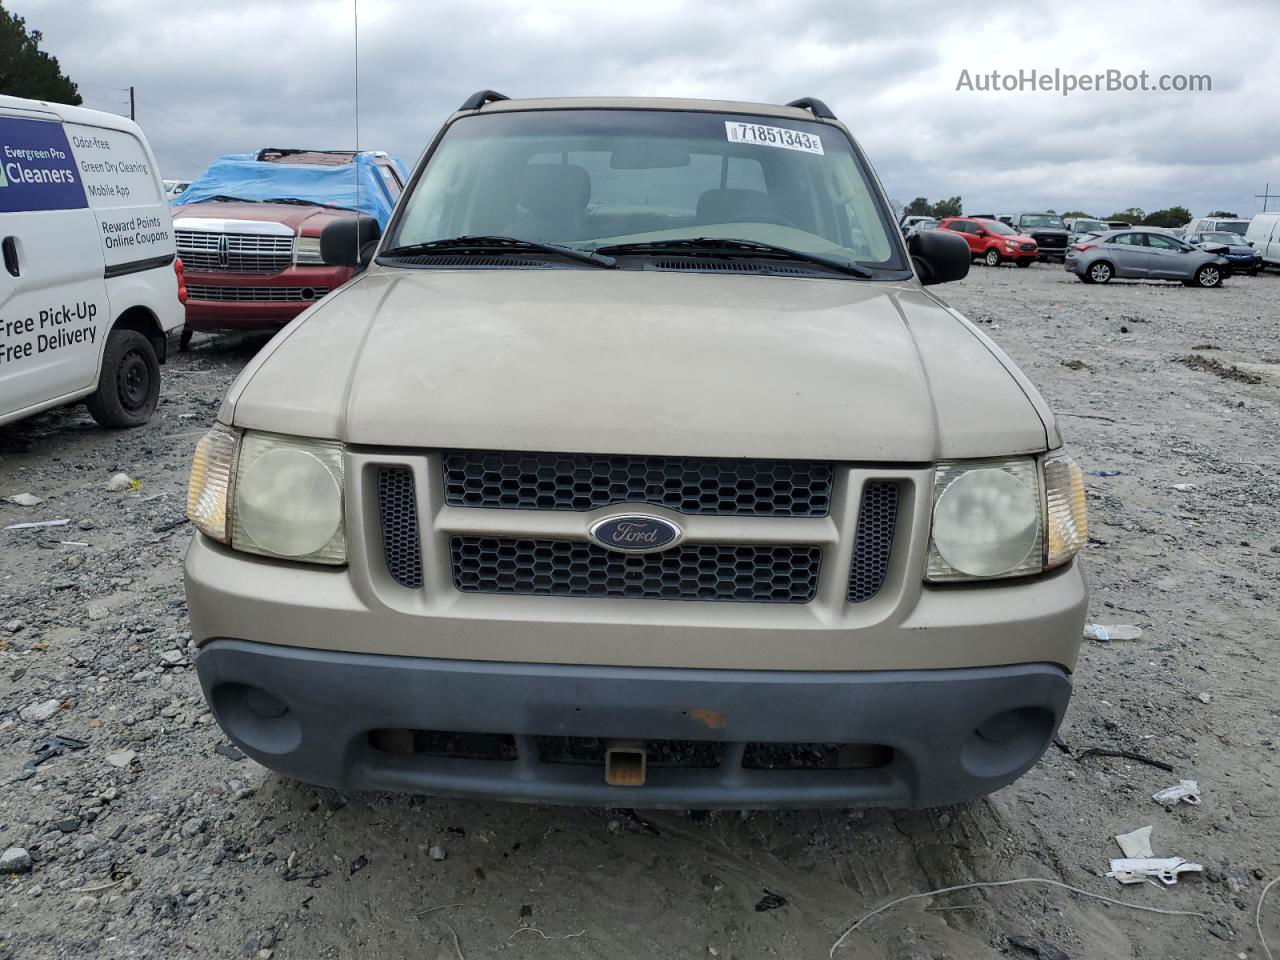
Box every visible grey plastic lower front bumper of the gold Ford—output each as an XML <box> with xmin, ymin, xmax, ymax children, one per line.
<box><xmin>196</xmin><ymin>640</ymin><xmax>1071</xmax><ymax>809</ymax></box>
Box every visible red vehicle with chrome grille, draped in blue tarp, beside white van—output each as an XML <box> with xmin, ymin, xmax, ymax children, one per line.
<box><xmin>173</xmin><ymin>150</ymin><xmax>404</xmax><ymax>348</ymax></box>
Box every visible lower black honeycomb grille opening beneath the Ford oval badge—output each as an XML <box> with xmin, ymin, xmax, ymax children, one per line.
<box><xmin>449</xmin><ymin>536</ymin><xmax>822</xmax><ymax>603</ymax></box>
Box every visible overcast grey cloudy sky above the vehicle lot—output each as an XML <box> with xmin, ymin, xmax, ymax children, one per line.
<box><xmin>5</xmin><ymin>0</ymin><xmax>1280</xmax><ymax>216</ymax></box>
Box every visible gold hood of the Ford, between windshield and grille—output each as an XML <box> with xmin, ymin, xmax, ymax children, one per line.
<box><xmin>219</xmin><ymin>268</ymin><xmax>1057</xmax><ymax>462</ymax></box>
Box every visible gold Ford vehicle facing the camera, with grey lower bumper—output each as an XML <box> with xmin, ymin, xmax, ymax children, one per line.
<box><xmin>186</xmin><ymin>91</ymin><xmax>1085</xmax><ymax>808</ymax></box>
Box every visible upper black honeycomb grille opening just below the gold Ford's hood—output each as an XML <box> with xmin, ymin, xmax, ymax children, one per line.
<box><xmin>445</xmin><ymin>450</ymin><xmax>835</xmax><ymax>517</ymax></box>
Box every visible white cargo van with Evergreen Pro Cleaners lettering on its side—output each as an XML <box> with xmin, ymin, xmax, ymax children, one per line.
<box><xmin>0</xmin><ymin>96</ymin><xmax>184</xmax><ymax>426</ymax></box>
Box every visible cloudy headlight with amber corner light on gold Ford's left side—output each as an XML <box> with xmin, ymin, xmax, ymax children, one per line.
<box><xmin>187</xmin><ymin>425</ymin><xmax>347</xmax><ymax>564</ymax></box>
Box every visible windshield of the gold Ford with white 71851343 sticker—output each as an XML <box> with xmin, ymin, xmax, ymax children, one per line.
<box><xmin>383</xmin><ymin>110</ymin><xmax>909</xmax><ymax>271</ymax></box>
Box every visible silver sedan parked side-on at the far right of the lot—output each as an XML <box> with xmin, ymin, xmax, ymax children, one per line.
<box><xmin>1065</xmin><ymin>229</ymin><xmax>1230</xmax><ymax>287</ymax></box>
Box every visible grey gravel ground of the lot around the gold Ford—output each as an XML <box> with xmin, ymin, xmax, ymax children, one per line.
<box><xmin>0</xmin><ymin>265</ymin><xmax>1280</xmax><ymax>960</ymax></box>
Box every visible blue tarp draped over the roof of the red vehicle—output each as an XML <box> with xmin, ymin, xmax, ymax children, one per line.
<box><xmin>173</xmin><ymin>152</ymin><xmax>408</xmax><ymax>227</ymax></box>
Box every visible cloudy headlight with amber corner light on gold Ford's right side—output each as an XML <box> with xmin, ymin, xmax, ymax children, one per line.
<box><xmin>925</xmin><ymin>452</ymin><xmax>1088</xmax><ymax>582</ymax></box>
